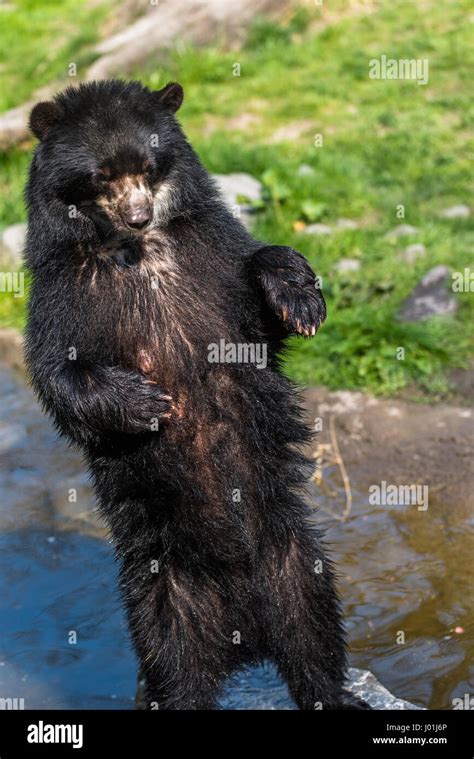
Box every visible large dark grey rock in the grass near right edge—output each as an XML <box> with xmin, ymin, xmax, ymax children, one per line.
<box><xmin>399</xmin><ymin>266</ymin><xmax>458</xmax><ymax>322</ymax></box>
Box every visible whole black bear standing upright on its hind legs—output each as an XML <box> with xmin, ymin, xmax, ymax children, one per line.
<box><xmin>26</xmin><ymin>81</ymin><xmax>366</xmax><ymax>710</ymax></box>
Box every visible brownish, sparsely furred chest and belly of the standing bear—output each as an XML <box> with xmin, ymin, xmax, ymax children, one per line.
<box><xmin>87</xmin><ymin>238</ymin><xmax>262</xmax><ymax>502</ymax></box>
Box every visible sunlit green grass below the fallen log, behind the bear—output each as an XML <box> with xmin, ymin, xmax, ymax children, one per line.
<box><xmin>0</xmin><ymin>0</ymin><xmax>474</xmax><ymax>397</ymax></box>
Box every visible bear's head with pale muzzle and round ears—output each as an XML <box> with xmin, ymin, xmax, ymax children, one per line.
<box><xmin>28</xmin><ymin>80</ymin><xmax>206</xmax><ymax>237</ymax></box>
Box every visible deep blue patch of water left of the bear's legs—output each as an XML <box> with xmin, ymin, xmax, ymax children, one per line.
<box><xmin>0</xmin><ymin>527</ymin><xmax>136</xmax><ymax>709</ymax></box>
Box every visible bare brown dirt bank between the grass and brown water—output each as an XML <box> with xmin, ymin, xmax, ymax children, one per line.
<box><xmin>304</xmin><ymin>388</ymin><xmax>474</xmax><ymax>512</ymax></box>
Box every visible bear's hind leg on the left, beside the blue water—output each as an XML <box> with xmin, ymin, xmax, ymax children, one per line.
<box><xmin>125</xmin><ymin>568</ymin><xmax>239</xmax><ymax>711</ymax></box>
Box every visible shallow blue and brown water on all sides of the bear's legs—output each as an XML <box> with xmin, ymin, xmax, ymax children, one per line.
<box><xmin>0</xmin><ymin>370</ymin><xmax>474</xmax><ymax>709</ymax></box>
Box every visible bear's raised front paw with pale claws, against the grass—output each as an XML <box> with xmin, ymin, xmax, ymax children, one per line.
<box><xmin>251</xmin><ymin>245</ymin><xmax>326</xmax><ymax>337</ymax></box>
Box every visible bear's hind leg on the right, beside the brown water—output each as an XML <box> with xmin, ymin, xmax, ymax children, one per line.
<box><xmin>264</xmin><ymin>529</ymin><xmax>369</xmax><ymax>710</ymax></box>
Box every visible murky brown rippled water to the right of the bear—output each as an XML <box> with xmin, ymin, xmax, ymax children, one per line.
<box><xmin>312</xmin><ymin>478</ymin><xmax>474</xmax><ymax>709</ymax></box>
